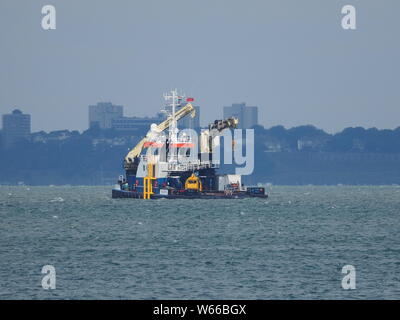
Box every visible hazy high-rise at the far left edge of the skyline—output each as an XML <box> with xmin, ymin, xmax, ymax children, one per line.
<box><xmin>2</xmin><ymin>109</ymin><xmax>31</xmax><ymax>147</ymax></box>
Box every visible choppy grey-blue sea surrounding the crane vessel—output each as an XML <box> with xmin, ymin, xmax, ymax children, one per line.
<box><xmin>0</xmin><ymin>186</ymin><xmax>400</xmax><ymax>299</ymax></box>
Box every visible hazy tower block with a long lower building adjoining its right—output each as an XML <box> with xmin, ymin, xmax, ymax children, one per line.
<box><xmin>89</xmin><ymin>102</ymin><xmax>124</xmax><ymax>129</ymax></box>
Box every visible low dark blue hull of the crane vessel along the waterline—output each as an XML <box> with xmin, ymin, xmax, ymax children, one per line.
<box><xmin>112</xmin><ymin>189</ymin><xmax>268</xmax><ymax>199</ymax></box>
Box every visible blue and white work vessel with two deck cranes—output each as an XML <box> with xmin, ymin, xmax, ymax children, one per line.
<box><xmin>112</xmin><ymin>89</ymin><xmax>268</xmax><ymax>199</ymax></box>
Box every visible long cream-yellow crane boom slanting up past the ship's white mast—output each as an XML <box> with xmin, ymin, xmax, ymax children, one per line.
<box><xmin>124</xmin><ymin>103</ymin><xmax>196</xmax><ymax>169</ymax></box>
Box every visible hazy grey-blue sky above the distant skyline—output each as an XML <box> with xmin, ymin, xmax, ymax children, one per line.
<box><xmin>0</xmin><ymin>0</ymin><xmax>400</xmax><ymax>132</ymax></box>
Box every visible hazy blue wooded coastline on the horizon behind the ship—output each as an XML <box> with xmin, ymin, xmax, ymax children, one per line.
<box><xmin>0</xmin><ymin>125</ymin><xmax>400</xmax><ymax>186</ymax></box>
